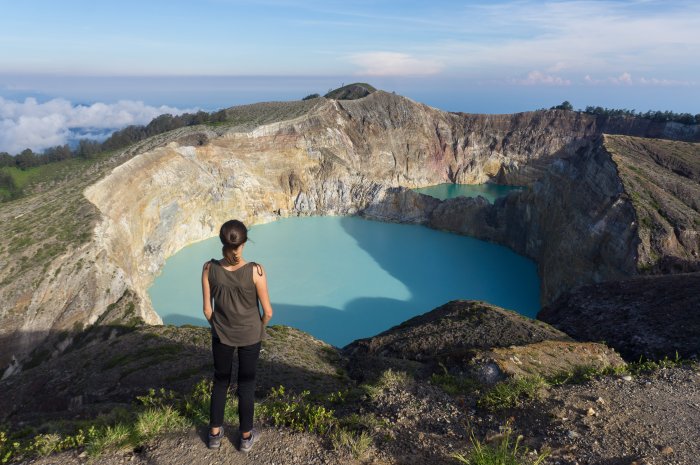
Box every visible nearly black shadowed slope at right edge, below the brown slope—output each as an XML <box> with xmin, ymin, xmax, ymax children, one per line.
<box><xmin>537</xmin><ymin>273</ymin><xmax>700</xmax><ymax>360</ymax></box>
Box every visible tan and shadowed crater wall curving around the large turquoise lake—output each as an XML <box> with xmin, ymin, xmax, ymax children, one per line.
<box><xmin>0</xmin><ymin>91</ymin><xmax>700</xmax><ymax>371</ymax></box>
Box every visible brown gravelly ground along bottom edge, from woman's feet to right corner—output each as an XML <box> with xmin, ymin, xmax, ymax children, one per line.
<box><xmin>15</xmin><ymin>368</ymin><xmax>700</xmax><ymax>465</ymax></box>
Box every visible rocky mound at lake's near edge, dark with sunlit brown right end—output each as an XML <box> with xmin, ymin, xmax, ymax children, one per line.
<box><xmin>343</xmin><ymin>300</ymin><xmax>624</xmax><ymax>384</ymax></box>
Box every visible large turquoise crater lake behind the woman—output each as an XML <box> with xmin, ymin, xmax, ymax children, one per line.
<box><xmin>149</xmin><ymin>216</ymin><xmax>539</xmax><ymax>347</ymax></box>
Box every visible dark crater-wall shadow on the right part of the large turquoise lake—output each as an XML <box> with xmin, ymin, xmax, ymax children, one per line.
<box><xmin>341</xmin><ymin>217</ymin><xmax>539</xmax><ymax>317</ymax></box>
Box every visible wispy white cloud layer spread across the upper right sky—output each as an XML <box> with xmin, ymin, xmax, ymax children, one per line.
<box><xmin>348</xmin><ymin>0</ymin><xmax>700</xmax><ymax>86</ymax></box>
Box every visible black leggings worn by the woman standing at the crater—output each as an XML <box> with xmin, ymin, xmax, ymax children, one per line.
<box><xmin>209</xmin><ymin>338</ymin><xmax>260</xmax><ymax>433</ymax></box>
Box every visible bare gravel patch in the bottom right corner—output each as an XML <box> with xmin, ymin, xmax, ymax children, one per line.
<box><xmin>518</xmin><ymin>368</ymin><xmax>700</xmax><ymax>465</ymax></box>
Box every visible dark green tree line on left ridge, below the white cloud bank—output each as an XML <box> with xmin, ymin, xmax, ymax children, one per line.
<box><xmin>0</xmin><ymin>110</ymin><xmax>226</xmax><ymax>170</ymax></box>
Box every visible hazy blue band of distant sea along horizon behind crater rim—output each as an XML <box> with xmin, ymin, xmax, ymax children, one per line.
<box><xmin>0</xmin><ymin>74</ymin><xmax>700</xmax><ymax>114</ymax></box>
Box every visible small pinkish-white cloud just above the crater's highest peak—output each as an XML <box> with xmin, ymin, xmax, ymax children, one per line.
<box><xmin>349</xmin><ymin>52</ymin><xmax>443</xmax><ymax>76</ymax></box>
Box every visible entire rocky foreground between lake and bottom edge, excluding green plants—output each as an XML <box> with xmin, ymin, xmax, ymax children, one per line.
<box><xmin>6</xmin><ymin>301</ymin><xmax>700</xmax><ymax>465</ymax></box>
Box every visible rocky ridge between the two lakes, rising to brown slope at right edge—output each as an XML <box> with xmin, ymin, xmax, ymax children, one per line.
<box><xmin>362</xmin><ymin>135</ymin><xmax>700</xmax><ymax>304</ymax></box>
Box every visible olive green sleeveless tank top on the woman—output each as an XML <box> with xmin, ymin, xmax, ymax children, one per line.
<box><xmin>209</xmin><ymin>258</ymin><xmax>265</xmax><ymax>347</ymax></box>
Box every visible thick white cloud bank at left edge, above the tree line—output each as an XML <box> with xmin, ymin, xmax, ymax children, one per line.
<box><xmin>0</xmin><ymin>97</ymin><xmax>193</xmax><ymax>154</ymax></box>
